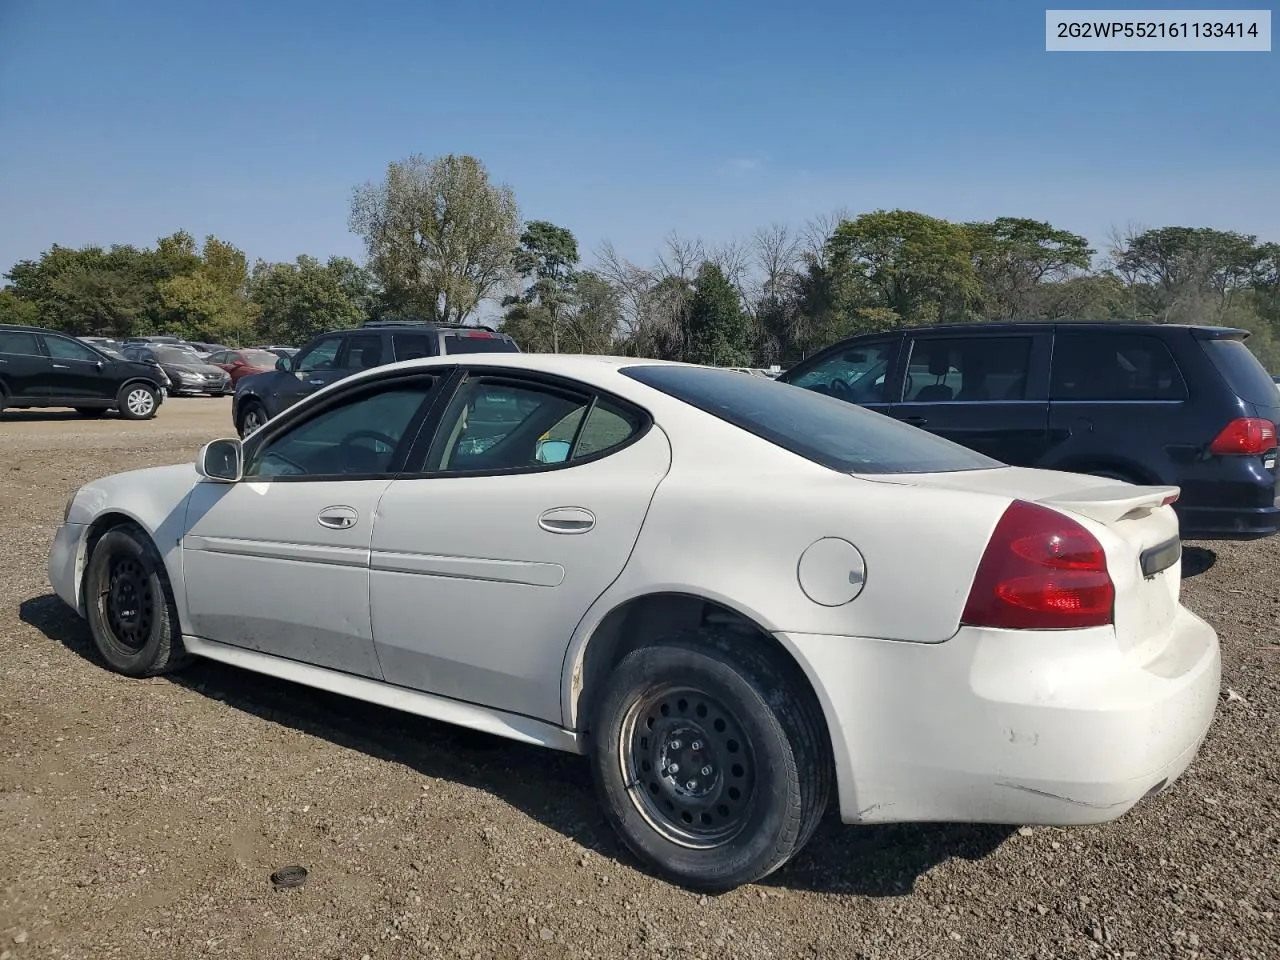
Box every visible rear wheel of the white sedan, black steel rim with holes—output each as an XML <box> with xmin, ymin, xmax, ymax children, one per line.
<box><xmin>591</xmin><ymin>631</ymin><xmax>831</xmax><ymax>891</ymax></box>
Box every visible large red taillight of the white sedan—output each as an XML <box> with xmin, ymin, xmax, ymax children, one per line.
<box><xmin>963</xmin><ymin>500</ymin><xmax>1115</xmax><ymax>630</ymax></box>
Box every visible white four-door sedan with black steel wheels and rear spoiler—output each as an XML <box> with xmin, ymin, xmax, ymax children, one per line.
<box><xmin>49</xmin><ymin>353</ymin><xmax>1220</xmax><ymax>890</ymax></box>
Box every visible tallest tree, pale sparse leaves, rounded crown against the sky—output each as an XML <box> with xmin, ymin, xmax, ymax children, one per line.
<box><xmin>349</xmin><ymin>154</ymin><xmax>520</xmax><ymax>323</ymax></box>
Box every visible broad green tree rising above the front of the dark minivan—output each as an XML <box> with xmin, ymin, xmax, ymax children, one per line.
<box><xmin>827</xmin><ymin>210</ymin><xmax>982</xmax><ymax>324</ymax></box>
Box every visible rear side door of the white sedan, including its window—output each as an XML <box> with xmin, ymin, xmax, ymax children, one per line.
<box><xmin>371</xmin><ymin>370</ymin><xmax>671</xmax><ymax>723</ymax></box>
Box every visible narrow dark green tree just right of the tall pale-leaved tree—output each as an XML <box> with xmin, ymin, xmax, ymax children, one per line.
<box><xmin>503</xmin><ymin>220</ymin><xmax>579</xmax><ymax>353</ymax></box>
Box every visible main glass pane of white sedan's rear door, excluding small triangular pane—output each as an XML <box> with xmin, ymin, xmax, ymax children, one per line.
<box><xmin>426</xmin><ymin>378</ymin><xmax>590</xmax><ymax>472</ymax></box>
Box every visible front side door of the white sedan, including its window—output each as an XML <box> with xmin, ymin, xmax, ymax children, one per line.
<box><xmin>182</xmin><ymin>374</ymin><xmax>438</xmax><ymax>678</ymax></box>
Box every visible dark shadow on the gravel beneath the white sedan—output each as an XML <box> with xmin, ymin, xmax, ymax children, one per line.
<box><xmin>18</xmin><ymin>594</ymin><xmax>1012</xmax><ymax>897</ymax></box>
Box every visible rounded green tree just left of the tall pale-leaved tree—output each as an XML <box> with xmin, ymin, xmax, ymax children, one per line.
<box><xmin>250</xmin><ymin>256</ymin><xmax>366</xmax><ymax>343</ymax></box>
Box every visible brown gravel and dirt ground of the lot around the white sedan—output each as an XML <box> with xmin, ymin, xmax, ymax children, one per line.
<box><xmin>0</xmin><ymin>399</ymin><xmax>1280</xmax><ymax>960</ymax></box>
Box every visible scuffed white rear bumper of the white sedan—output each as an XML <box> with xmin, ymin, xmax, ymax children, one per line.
<box><xmin>778</xmin><ymin>608</ymin><xmax>1221</xmax><ymax>826</ymax></box>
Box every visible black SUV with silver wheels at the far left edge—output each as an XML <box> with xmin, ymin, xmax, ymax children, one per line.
<box><xmin>0</xmin><ymin>324</ymin><xmax>165</xmax><ymax>420</ymax></box>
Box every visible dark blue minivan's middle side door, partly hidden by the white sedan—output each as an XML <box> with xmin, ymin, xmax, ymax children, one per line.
<box><xmin>890</xmin><ymin>328</ymin><xmax>1052</xmax><ymax>466</ymax></box>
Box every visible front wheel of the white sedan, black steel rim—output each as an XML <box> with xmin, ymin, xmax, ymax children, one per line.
<box><xmin>84</xmin><ymin>526</ymin><xmax>187</xmax><ymax>677</ymax></box>
